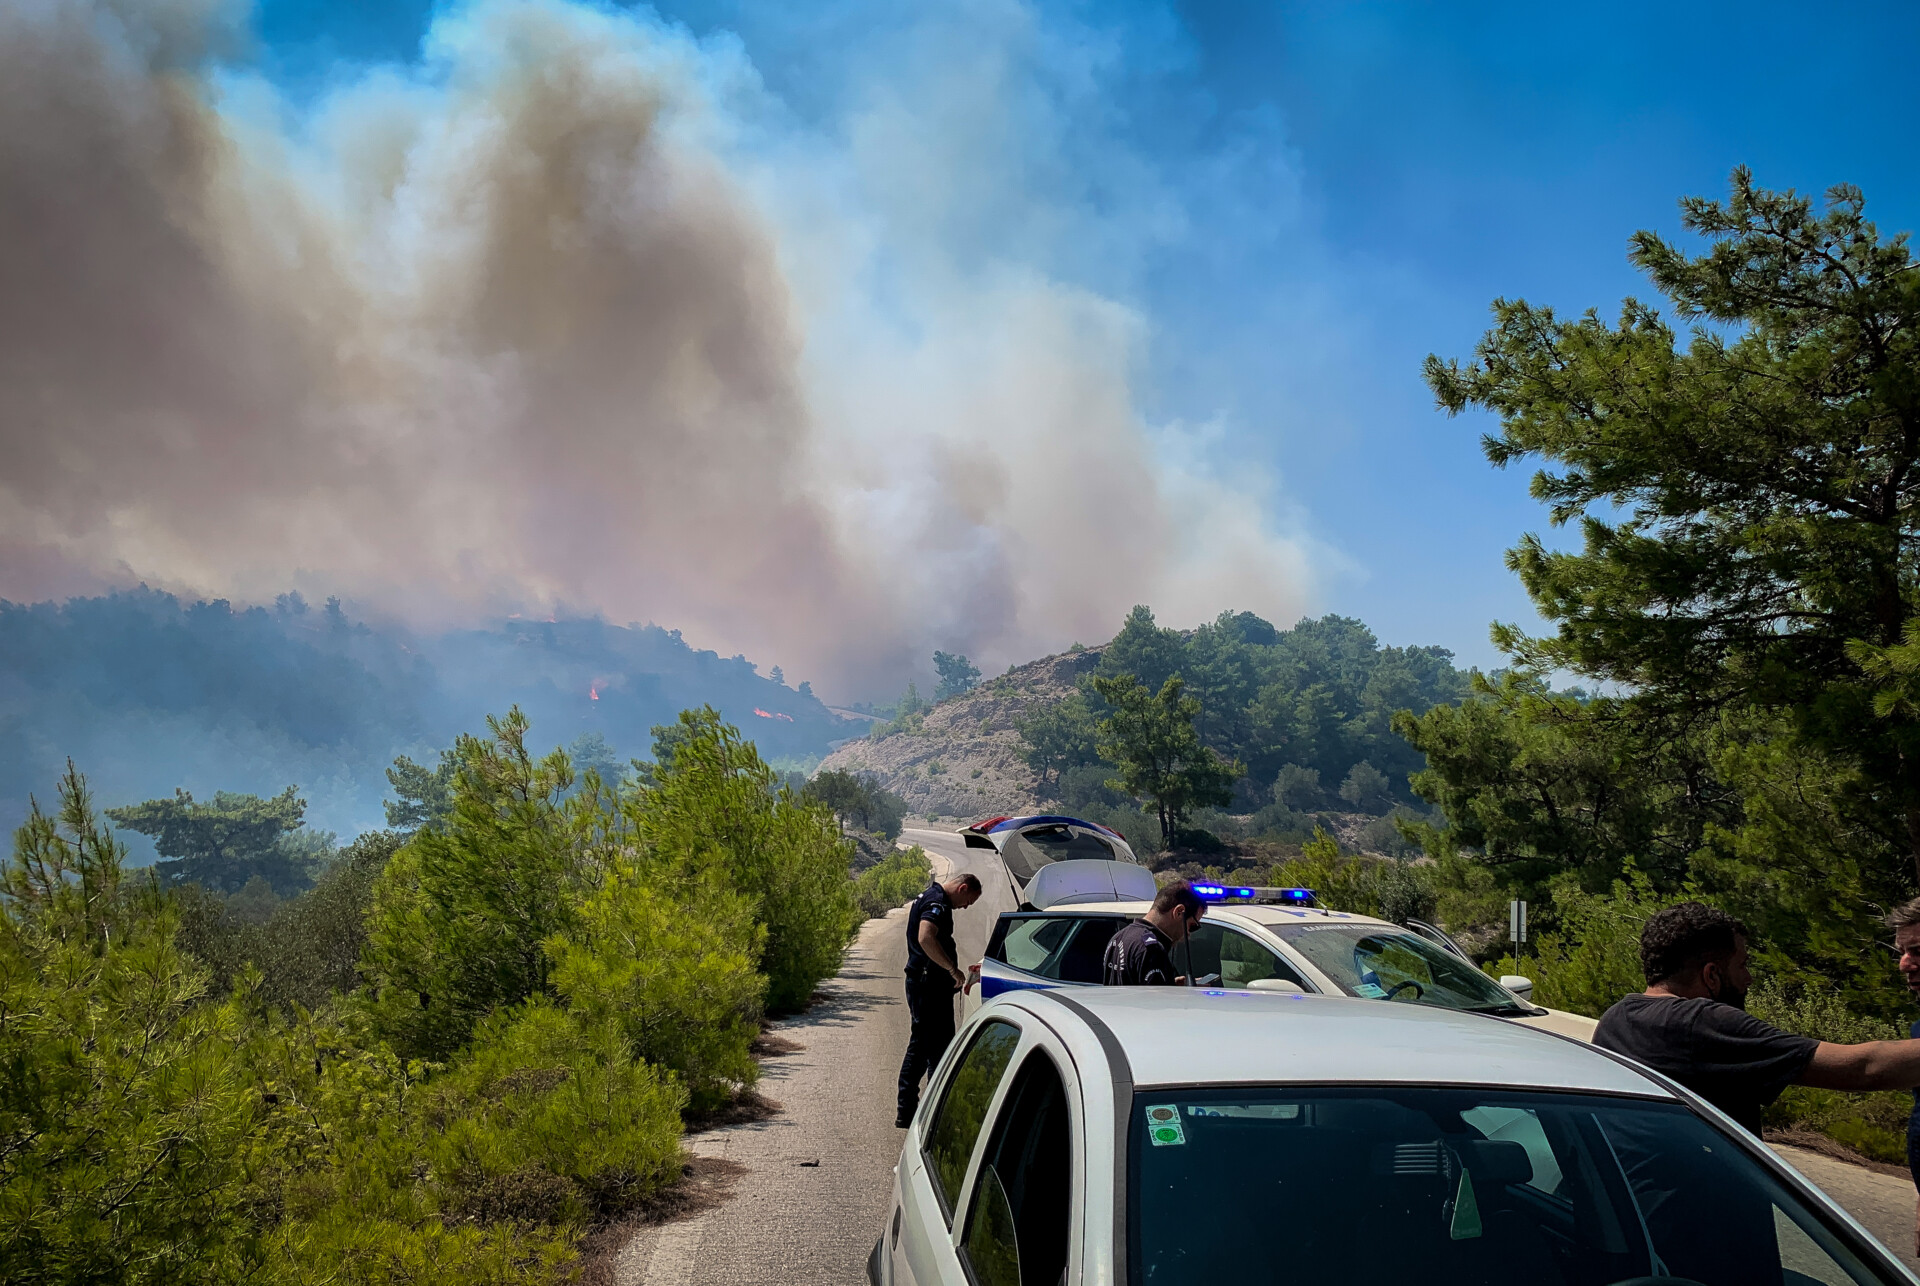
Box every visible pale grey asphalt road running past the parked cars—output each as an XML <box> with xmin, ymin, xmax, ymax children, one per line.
<box><xmin>614</xmin><ymin>829</ymin><xmax>1920</xmax><ymax>1286</ymax></box>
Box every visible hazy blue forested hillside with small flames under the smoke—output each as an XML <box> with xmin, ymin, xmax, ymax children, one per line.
<box><xmin>0</xmin><ymin>589</ymin><xmax>858</xmax><ymax>833</ymax></box>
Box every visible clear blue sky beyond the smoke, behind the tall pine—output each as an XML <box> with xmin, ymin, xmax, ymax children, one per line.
<box><xmin>255</xmin><ymin>0</ymin><xmax>1920</xmax><ymax>664</ymax></box>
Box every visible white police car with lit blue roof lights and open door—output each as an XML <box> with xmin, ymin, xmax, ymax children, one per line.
<box><xmin>964</xmin><ymin>860</ymin><xmax>1596</xmax><ymax>1040</ymax></box>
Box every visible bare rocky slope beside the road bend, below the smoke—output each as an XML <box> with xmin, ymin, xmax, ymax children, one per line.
<box><xmin>820</xmin><ymin>647</ymin><xmax>1102</xmax><ymax>818</ymax></box>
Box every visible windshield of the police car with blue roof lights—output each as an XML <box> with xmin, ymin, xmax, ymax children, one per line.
<box><xmin>1273</xmin><ymin>921</ymin><xmax>1532</xmax><ymax>1015</ymax></box>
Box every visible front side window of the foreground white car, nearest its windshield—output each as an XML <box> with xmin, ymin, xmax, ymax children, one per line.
<box><xmin>960</xmin><ymin>1050</ymin><xmax>1073</xmax><ymax>1286</ymax></box>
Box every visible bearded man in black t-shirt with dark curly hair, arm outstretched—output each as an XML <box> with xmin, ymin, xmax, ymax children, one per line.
<box><xmin>1594</xmin><ymin>902</ymin><xmax>1920</xmax><ymax>1134</ymax></box>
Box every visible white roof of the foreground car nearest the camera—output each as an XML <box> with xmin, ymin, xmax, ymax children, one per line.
<box><xmin>987</xmin><ymin>987</ymin><xmax>1674</xmax><ymax>1100</ymax></box>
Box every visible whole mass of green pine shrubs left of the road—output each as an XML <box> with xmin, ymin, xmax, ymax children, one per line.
<box><xmin>0</xmin><ymin>710</ymin><xmax>854</xmax><ymax>1286</ymax></box>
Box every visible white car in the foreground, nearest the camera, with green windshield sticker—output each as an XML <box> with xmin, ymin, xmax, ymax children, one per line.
<box><xmin>868</xmin><ymin>987</ymin><xmax>1920</xmax><ymax>1286</ymax></box>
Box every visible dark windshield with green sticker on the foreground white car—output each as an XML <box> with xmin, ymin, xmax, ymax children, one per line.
<box><xmin>1127</xmin><ymin>1086</ymin><xmax>1901</xmax><ymax>1286</ymax></box>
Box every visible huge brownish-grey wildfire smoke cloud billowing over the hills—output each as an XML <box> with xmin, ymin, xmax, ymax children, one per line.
<box><xmin>0</xmin><ymin>0</ymin><xmax>1309</xmax><ymax>695</ymax></box>
